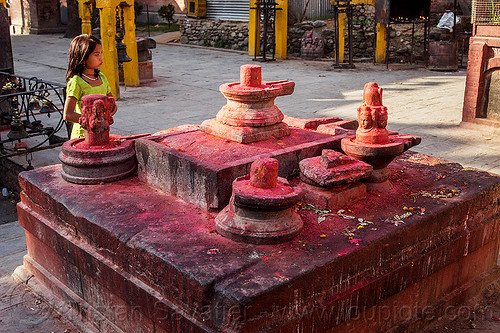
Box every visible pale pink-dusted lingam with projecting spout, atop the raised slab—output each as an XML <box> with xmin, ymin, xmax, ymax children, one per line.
<box><xmin>200</xmin><ymin>65</ymin><xmax>295</xmax><ymax>143</ymax></box>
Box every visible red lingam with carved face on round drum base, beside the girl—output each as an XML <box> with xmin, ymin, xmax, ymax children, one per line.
<box><xmin>59</xmin><ymin>95</ymin><xmax>137</xmax><ymax>184</ymax></box>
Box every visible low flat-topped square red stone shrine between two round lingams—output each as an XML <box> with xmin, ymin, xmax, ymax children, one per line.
<box><xmin>299</xmin><ymin>149</ymin><xmax>373</xmax><ymax>210</ymax></box>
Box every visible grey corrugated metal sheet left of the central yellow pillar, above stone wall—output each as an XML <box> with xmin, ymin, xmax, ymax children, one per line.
<box><xmin>207</xmin><ymin>0</ymin><xmax>250</xmax><ymax>22</ymax></box>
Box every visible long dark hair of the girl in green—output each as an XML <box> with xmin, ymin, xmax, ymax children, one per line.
<box><xmin>66</xmin><ymin>34</ymin><xmax>101</xmax><ymax>82</ymax></box>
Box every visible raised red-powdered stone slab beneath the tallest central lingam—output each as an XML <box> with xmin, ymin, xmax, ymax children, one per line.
<box><xmin>135</xmin><ymin>128</ymin><xmax>342</xmax><ymax>209</ymax></box>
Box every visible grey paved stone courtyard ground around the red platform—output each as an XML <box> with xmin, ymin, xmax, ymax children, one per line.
<box><xmin>0</xmin><ymin>35</ymin><xmax>500</xmax><ymax>332</ymax></box>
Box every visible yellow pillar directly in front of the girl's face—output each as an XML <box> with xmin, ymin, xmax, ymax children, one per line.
<box><xmin>96</xmin><ymin>0</ymin><xmax>120</xmax><ymax>99</ymax></box>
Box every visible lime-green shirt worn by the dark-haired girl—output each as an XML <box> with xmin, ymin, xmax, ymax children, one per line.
<box><xmin>66</xmin><ymin>73</ymin><xmax>111</xmax><ymax>139</ymax></box>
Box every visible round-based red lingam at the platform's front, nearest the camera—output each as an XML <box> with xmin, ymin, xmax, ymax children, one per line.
<box><xmin>215</xmin><ymin>158</ymin><xmax>303</xmax><ymax>244</ymax></box>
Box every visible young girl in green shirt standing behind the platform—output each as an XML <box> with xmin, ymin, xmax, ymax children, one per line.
<box><xmin>63</xmin><ymin>34</ymin><xmax>116</xmax><ymax>139</ymax></box>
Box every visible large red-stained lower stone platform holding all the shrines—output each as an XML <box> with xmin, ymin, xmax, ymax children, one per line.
<box><xmin>16</xmin><ymin>151</ymin><xmax>500</xmax><ymax>332</ymax></box>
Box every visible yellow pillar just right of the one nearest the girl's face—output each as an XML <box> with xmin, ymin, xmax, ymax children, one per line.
<box><xmin>123</xmin><ymin>1</ymin><xmax>140</xmax><ymax>87</ymax></box>
